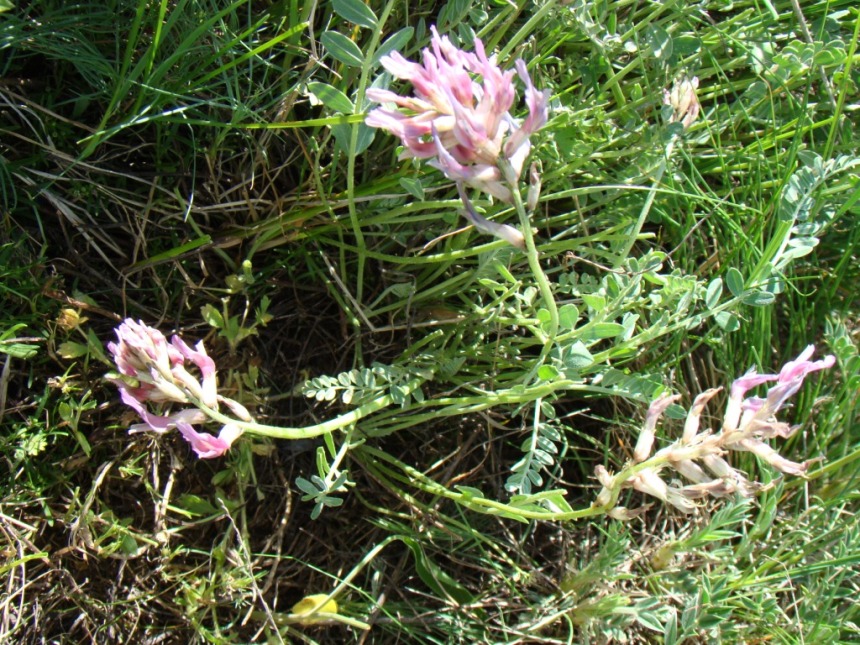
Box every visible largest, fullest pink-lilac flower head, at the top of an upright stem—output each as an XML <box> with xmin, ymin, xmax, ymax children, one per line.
<box><xmin>366</xmin><ymin>27</ymin><xmax>550</xmax><ymax>202</ymax></box>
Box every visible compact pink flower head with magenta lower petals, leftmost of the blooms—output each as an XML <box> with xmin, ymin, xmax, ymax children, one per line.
<box><xmin>108</xmin><ymin>318</ymin><xmax>245</xmax><ymax>459</ymax></box>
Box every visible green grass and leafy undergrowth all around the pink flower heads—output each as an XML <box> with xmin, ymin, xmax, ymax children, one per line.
<box><xmin>0</xmin><ymin>0</ymin><xmax>860</xmax><ymax>644</ymax></box>
